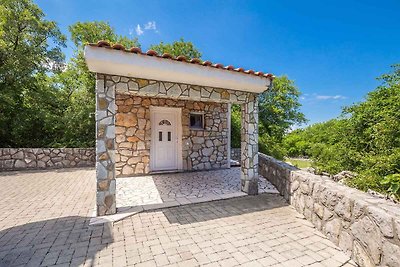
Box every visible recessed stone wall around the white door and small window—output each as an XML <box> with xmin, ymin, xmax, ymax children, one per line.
<box><xmin>115</xmin><ymin>93</ymin><xmax>230</xmax><ymax>176</ymax></box>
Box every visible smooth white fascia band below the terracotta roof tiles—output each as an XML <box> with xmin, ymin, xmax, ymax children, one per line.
<box><xmin>85</xmin><ymin>45</ymin><xmax>273</xmax><ymax>93</ymax></box>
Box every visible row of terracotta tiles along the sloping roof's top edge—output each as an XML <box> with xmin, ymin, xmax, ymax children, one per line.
<box><xmin>89</xmin><ymin>41</ymin><xmax>275</xmax><ymax>79</ymax></box>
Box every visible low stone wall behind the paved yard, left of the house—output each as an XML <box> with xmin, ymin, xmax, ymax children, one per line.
<box><xmin>0</xmin><ymin>148</ymin><xmax>96</xmax><ymax>171</ymax></box>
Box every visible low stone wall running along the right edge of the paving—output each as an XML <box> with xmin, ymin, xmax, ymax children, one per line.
<box><xmin>259</xmin><ymin>153</ymin><xmax>400</xmax><ymax>266</ymax></box>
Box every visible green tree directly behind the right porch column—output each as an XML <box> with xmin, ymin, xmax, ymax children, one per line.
<box><xmin>231</xmin><ymin>76</ymin><xmax>306</xmax><ymax>159</ymax></box>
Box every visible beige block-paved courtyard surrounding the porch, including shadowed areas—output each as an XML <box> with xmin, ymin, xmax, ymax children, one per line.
<box><xmin>0</xmin><ymin>169</ymin><xmax>355</xmax><ymax>267</ymax></box>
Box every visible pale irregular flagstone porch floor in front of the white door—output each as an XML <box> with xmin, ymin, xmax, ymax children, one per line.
<box><xmin>117</xmin><ymin>167</ymin><xmax>279</xmax><ymax>212</ymax></box>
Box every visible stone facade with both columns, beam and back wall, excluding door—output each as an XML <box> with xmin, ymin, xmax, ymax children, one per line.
<box><xmin>96</xmin><ymin>74</ymin><xmax>258</xmax><ymax>218</ymax></box>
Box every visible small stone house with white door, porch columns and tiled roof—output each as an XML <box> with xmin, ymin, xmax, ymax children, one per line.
<box><xmin>85</xmin><ymin>41</ymin><xmax>273</xmax><ymax>218</ymax></box>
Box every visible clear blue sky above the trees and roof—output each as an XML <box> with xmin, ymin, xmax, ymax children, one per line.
<box><xmin>35</xmin><ymin>0</ymin><xmax>400</xmax><ymax>126</ymax></box>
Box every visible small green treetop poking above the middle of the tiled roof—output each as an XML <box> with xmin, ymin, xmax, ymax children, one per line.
<box><xmin>150</xmin><ymin>38</ymin><xmax>201</xmax><ymax>59</ymax></box>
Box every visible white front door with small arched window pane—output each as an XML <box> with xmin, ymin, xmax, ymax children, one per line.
<box><xmin>150</xmin><ymin>107</ymin><xmax>181</xmax><ymax>171</ymax></box>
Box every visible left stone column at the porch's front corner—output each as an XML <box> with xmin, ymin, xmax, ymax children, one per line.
<box><xmin>96</xmin><ymin>74</ymin><xmax>117</xmax><ymax>216</ymax></box>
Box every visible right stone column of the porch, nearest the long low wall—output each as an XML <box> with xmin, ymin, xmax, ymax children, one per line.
<box><xmin>240</xmin><ymin>94</ymin><xmax>258</xmax><ymax>195</ymax></box>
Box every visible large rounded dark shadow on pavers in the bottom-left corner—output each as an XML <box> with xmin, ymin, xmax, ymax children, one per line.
<box><xmin>0</xmin><ymin>216</ymin><xmax>113</xmax><ymax>267</ymax></box>
